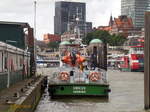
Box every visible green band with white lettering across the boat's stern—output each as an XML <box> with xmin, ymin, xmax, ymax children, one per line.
<box><xmin>49</xmin><ymin>85</ymin><xmax>109</xmax><ymax>96</ymax></box>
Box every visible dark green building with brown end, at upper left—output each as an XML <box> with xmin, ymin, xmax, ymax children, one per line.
<box><xmin>0</xmin><ymin>21</ymin><xmax>33</xmax><ymax>49</ymax></box>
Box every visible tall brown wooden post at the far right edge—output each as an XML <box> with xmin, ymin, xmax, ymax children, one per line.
<box><xmin>144</xmin><ymin>12</ymin><xmax>150</xmax><ymax>109</ymax></box>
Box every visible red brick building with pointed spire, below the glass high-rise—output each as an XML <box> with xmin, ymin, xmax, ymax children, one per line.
<box><xmin>97</xmin><ymin>16</ymin><xmax>141</xmax><ymax>37</ymax></box>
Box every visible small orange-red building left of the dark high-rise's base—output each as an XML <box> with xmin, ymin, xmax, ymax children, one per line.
<box><xmin>43</xmin><ymin>33</ymin><xmax>61</xmax><ymax>44</ymax></box>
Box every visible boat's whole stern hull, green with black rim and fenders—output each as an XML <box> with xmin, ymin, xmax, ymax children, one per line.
<box><xmin>48</xmin><ymin>84</ymin><xmax>110</xmax><ymax>97</ymax></box>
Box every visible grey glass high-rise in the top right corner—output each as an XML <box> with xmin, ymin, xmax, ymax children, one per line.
<box><xmin>121</xmin><ymin>0</ymin><xmax>150</xmax><ymax>28</ymax></box>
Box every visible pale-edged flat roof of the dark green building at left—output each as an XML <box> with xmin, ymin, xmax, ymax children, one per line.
<box><xmin>0</xmin><ymin>21</ymin><xmax>30</xmax><ymax>27</ymax></box>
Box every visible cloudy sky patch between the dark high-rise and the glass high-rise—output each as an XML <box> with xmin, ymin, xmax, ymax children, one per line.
<box><xmin>87</xmin><ymin>0</ymin><xmax>120</xmax><ymax>26</ymax></box>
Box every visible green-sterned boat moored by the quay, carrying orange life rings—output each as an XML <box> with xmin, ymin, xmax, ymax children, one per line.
<box><xmin>48</xmin><ymin>39</ymin><xmax>110</xmax><ymax>98</ymax></box>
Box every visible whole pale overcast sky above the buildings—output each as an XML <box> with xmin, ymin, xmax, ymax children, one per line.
<box><xmin>0</xmin><ymin>0</ymin><xmax>121</xmax><ymax>40</ymax></box>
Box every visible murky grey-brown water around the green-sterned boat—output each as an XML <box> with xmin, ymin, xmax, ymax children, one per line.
<box><xmin>35</xmin><ymin>70</ymin><xmax>148</xmax><ymax>112</ymax></box>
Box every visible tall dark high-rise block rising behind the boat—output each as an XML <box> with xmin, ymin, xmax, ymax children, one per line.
<box><xmin>54</xmin><ymin>1</ymin><xmax>92</xmax><ymax>35</ymax></box>
